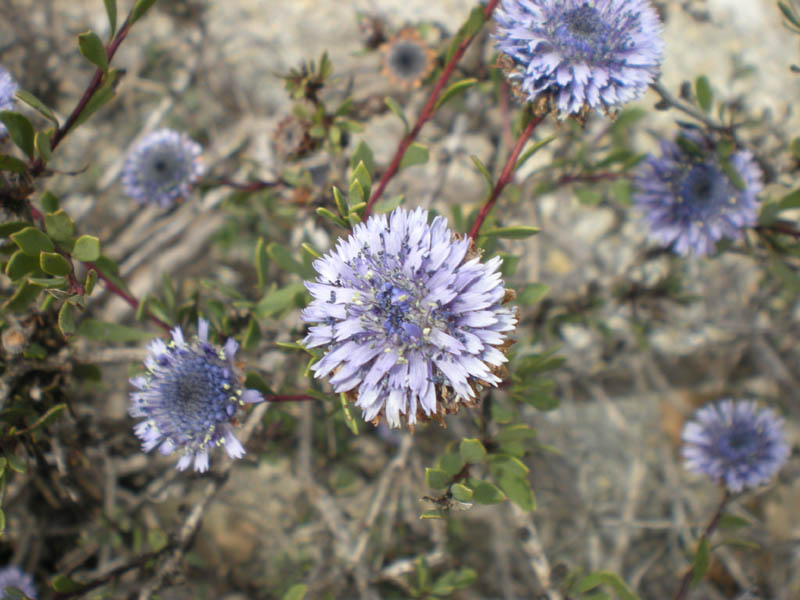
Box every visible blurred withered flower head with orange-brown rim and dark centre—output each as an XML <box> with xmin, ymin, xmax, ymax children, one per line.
<box><xmin>380</xmin><ymin>27</ymin><xmax>436</xmax><ymax>89</ymax></box>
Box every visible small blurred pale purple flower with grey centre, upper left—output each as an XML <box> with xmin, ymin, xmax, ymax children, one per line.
<box><xmin>122</xmin><ymin>129</ymin><xmax>204</xmax><ymax>208</ymax></box>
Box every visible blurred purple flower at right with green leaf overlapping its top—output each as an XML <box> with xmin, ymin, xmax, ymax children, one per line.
<box><xmin>633</xmin><ymin>132</ymin><xmax>763</xmax><ymax>256</ymax></box>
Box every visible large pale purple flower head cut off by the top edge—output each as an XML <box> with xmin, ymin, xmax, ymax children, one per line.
<box><xmin>495</xmin><ymin>0</ymin><xmax>664</xmax><ymax>114</ymax></box>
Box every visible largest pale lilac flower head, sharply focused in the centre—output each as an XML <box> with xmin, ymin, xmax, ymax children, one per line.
<box><xmin>302</xmin><ymin>208</ymin><xmax>516</xmax><ymax>427</ymax></box>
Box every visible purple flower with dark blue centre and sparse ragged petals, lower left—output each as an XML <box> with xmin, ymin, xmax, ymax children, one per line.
<box><xmin>128</xmin><ymin>319</ymin><xmax>263</xmax><ymax>472</ymax></box>
